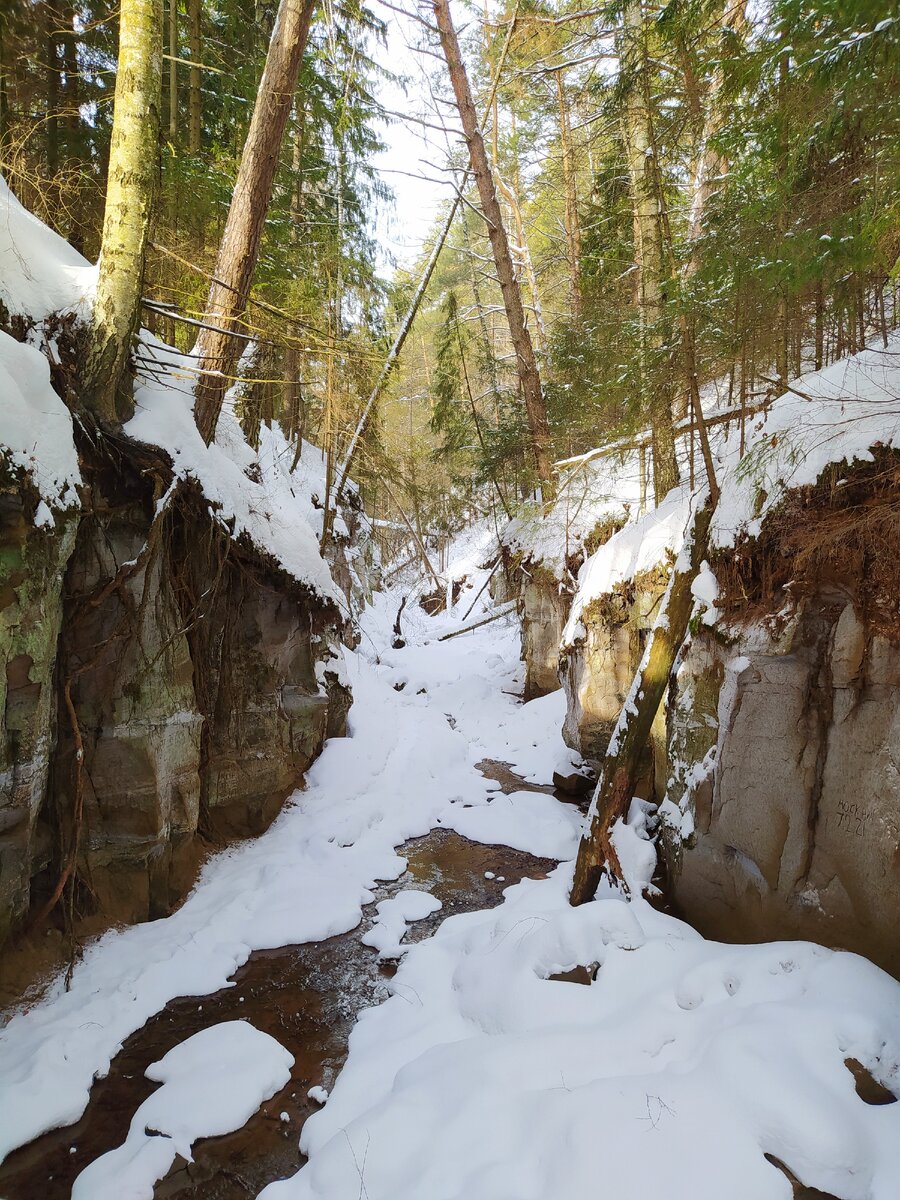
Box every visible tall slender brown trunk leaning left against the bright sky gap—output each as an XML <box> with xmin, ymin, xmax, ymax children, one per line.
<box><xmin>433</xmin><ymin>0</ymin><xmax>554</xmax><ymax>499</ymax></box>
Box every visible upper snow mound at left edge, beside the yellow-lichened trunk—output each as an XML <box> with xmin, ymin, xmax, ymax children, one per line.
<box><xmin>0</xmin><ymin>175</ymin><xmax>97</xmax><ymax>322</ymax></box>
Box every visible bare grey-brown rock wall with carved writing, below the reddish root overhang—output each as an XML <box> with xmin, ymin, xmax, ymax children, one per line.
<box><xmin>664</xmin><ymin>587</ymin><xmax>900</xmax><ymax>973</ymax></box>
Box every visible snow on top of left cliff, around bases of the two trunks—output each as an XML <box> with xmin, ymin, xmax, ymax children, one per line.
<box><xmin>0</xmin><ymin>178</ymin><xmax>342</xmax><ymax>605</ymax></box>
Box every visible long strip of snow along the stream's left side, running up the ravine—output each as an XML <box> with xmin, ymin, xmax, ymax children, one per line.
<box><xmin>0</xmin><ymin>595</ymin><xmax>572</xmax><ymax>1158</ymax></box>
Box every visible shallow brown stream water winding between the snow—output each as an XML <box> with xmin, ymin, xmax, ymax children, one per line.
<box><xmin>0</xmin><ymin>830</ymin><xmax>556</xmax><ymax>1200</ymax></box>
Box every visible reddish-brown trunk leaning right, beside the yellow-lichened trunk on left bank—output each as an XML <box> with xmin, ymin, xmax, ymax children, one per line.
<box><xmin>194</xmin><ymin>0</ymin><xmax>316</xmax><ymax>444</ymax></box>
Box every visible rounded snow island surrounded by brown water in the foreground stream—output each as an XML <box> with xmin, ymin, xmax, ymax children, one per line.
<box><xmin>72</xmin><ymin>1021</ymin><xmax>294</xmax><ymax>1200</ymax></box>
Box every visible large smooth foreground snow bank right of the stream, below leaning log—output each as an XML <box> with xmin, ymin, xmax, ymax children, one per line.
<box><xmin>260</xmin><ymin>811</ymin><xmax>900</xmax><ymax>1200</ymax></box>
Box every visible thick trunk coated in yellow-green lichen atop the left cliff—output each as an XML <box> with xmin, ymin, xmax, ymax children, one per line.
<box><xmin>84</xmin><ymin>0</ymin><xmax>162</xmax><ymax>424</ymax></box>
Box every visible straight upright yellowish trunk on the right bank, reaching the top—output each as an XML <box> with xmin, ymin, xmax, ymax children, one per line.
<box><xmin>622</xmin><ymin>0</ymin><xmax>678</xmax><ymax>504</ymax></box>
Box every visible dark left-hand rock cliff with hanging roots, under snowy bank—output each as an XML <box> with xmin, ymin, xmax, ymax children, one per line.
<box><xmin>0</xmin><ymin>450</ymin><xmax>349</xmax><ymax>960</ymax></box>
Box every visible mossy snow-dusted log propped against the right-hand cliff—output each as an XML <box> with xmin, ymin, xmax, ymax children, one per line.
<box><xmin>569</xmin><ymin>502</ymin><xmax>714</xmax><ymax>905</ymax></box>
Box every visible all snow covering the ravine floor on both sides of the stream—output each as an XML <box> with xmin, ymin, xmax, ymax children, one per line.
<box><xmin>0</xmin><ymin>585</ymin><xmax>900</xmax><ymax>1200</ymax></box>
